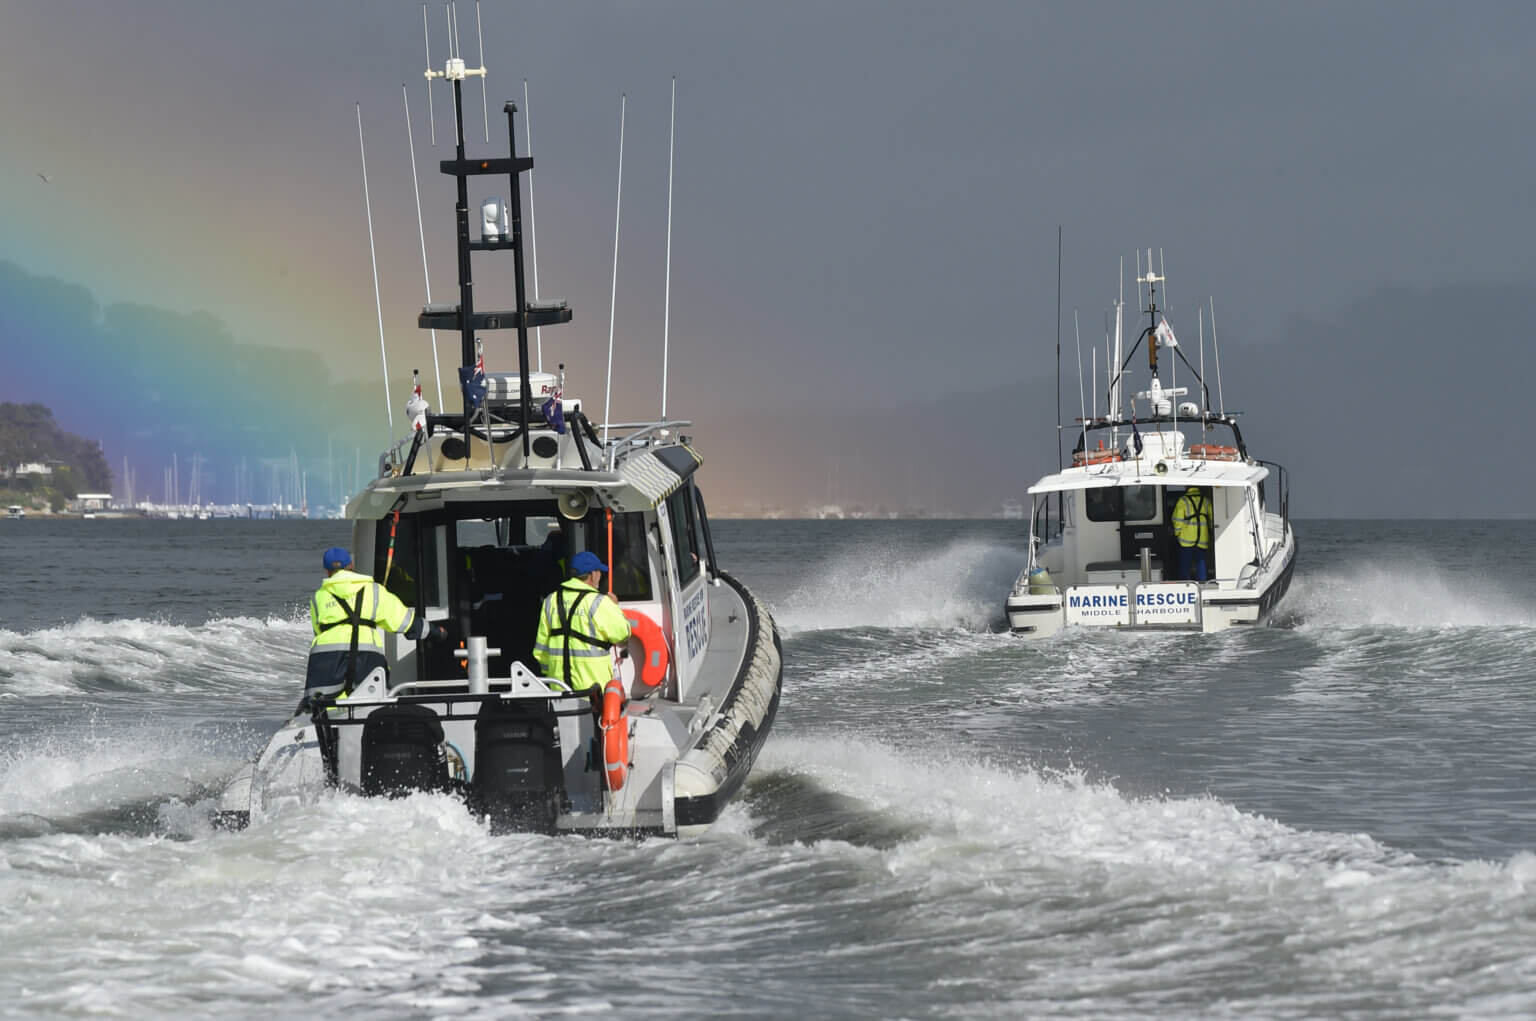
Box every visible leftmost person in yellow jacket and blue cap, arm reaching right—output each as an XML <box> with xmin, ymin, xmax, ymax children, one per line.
<box><xmin>304</xmin><ymin>547</ymin><xmax>449</xmax><ymax>699</ymax></box>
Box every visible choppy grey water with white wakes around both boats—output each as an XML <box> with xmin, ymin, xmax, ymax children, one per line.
<box><xmin>0</xmin><ymin>520</ymin><xmax>1536</xmax><ymax>1018</ymax></box>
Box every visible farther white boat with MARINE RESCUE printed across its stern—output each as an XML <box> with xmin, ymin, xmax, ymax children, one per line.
<box><xmin>1006</xmin><ymin>252</ymin><xmax>1296</xmax><ymax>637</ymax></box>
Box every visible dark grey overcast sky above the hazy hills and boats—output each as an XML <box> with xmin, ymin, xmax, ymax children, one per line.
<box><xmin>0</xmin><ymin>0</ymin><xmax>1536</xmax><ymax>514</ymax></box>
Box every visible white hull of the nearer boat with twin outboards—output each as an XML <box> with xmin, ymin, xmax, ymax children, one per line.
<box><xmin>217</xmin><ymin>573</ymin><xmax>783</xmax><ymax>837</ymax></box>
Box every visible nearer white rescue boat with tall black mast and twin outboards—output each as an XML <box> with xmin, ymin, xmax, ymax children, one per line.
<box><xmin>220</xmin><ymin>39</ymin><xmax>782</xmax><ymax>837</ymax></box>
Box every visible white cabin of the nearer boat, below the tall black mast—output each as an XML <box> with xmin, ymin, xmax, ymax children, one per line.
<box><xmin>349</xmin><ymin>445</ymin><xmax>713</xmax><ymax>700</ymax></box>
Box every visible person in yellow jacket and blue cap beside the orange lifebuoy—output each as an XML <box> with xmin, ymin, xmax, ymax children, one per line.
<box><xmin>533</xmin><ymin>550</ymin><xmax>630</xmax><ymax>697</ymax></box>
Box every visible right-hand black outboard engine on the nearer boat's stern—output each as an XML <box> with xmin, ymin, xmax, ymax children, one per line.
<box><xmin>470</xmin><ymin>699</ymin><xmax>565</xmax><ymax>832</ymax></box>
